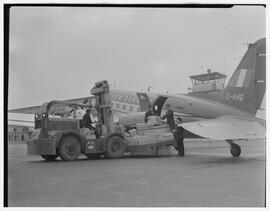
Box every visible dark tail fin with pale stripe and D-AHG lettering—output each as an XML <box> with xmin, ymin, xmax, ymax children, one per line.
<box><xmin>223</xmin><ymin>38</ymin><xmax>266</xmax><ymax>115</ymax></box>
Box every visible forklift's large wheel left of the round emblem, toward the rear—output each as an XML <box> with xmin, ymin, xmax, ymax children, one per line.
<box><xmin>59</xmin><ymin>136</ymin><xmax>81</xmax><ymax>161</ymax></box>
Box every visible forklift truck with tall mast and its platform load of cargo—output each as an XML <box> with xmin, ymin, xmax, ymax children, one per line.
<box><xmin>27</xmin><ymin>81</ymin><xmax>174</xmax><ymax>161</ymax></box>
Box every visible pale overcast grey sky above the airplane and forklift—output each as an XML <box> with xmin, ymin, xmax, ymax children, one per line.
<box><xmin>8</xmin><ymin>6</ymin><xmax>266</xmax><ymax>109</ymax></box>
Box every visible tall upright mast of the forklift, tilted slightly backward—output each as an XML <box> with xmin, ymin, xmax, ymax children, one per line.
<box><xmin>91</xmin><ymin>81</ymin><xmax>115</xmax><ymax>133</ymax></box>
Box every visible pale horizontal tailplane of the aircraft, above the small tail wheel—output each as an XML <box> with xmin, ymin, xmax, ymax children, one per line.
<box><xmin>181</xmin><ymin>116</ymin><xmax>266</xmax><ymax>140</ymax></box>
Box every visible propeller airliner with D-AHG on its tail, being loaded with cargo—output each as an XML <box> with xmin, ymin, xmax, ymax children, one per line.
<box><xmin>8</xmin><ymin>38</ymin><xmax>266</xmax><ymax>157</ymax></box>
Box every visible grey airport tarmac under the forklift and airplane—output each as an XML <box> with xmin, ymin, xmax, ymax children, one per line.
<box><xmin>8</xmin><ymin>140</ymin><xmax>266</xmax><ymax>207</ymax></box>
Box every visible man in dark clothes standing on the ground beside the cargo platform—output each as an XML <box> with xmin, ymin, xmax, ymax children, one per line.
<box><xmin>173</xmin><ymin>117</ymin><xmax>185</xmax><ymax>157</ymax></box>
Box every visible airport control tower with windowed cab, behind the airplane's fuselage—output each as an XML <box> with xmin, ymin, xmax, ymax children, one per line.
<box><xmin>189</xmin><ymin>69</ymin><xmax>227</xmax><ymax>94</ymax></box>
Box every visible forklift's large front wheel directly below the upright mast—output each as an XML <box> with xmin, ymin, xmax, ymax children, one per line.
<box><xmin>104</xmin><ymin>135</ymin><xmax>125</xmax><ymax>158</ymax></box>
